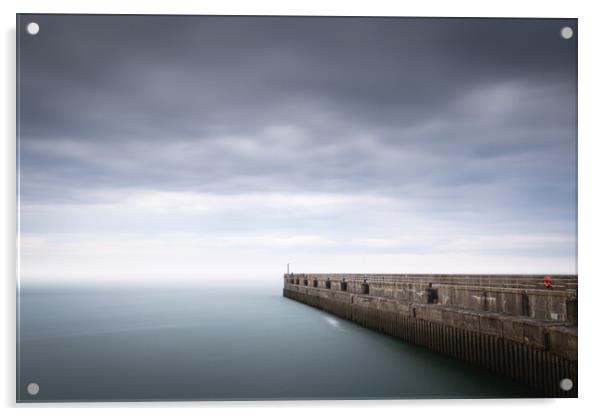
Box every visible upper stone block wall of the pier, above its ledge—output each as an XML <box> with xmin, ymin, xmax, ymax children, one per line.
<box><xmin>285</xmin><ymin>274</ymin><xmax>577</xmax><ymax>322</ymax></box>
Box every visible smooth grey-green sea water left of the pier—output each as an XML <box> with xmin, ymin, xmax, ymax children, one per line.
<box><xmin>17</xmin><ymin>287</ymin><xmax>533</xmax><ymax>401</ymax></box>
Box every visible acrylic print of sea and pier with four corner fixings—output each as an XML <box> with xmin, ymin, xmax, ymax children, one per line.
<box><xmin>16</xmin><ymin>14</ymin><xmax>578</xmax><ymax>402</ymax></box>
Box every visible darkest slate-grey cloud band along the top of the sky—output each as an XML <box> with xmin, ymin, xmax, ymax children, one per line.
<box><xmin>20</xmin><ymin>16</ymin><xmax>575</xmax><ymax>139</ymax></box>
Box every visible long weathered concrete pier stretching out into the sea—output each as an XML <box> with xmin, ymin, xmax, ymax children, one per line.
<box><xmin>283</xmin><ymin>274</ymin><xmax>578</xmax><ymax>397</ymax></box>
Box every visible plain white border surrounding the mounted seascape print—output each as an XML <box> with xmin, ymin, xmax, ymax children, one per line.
<box><xmin>0</xmin><ymin>0</ymin><xmax>602</xmax><ymax>416</ymax></box>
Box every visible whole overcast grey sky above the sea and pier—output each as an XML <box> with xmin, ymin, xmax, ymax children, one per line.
<box><xmin>18</xmin><ymin>15</ymin><xmax>577</xmax><ymax>284</ymax></box>
